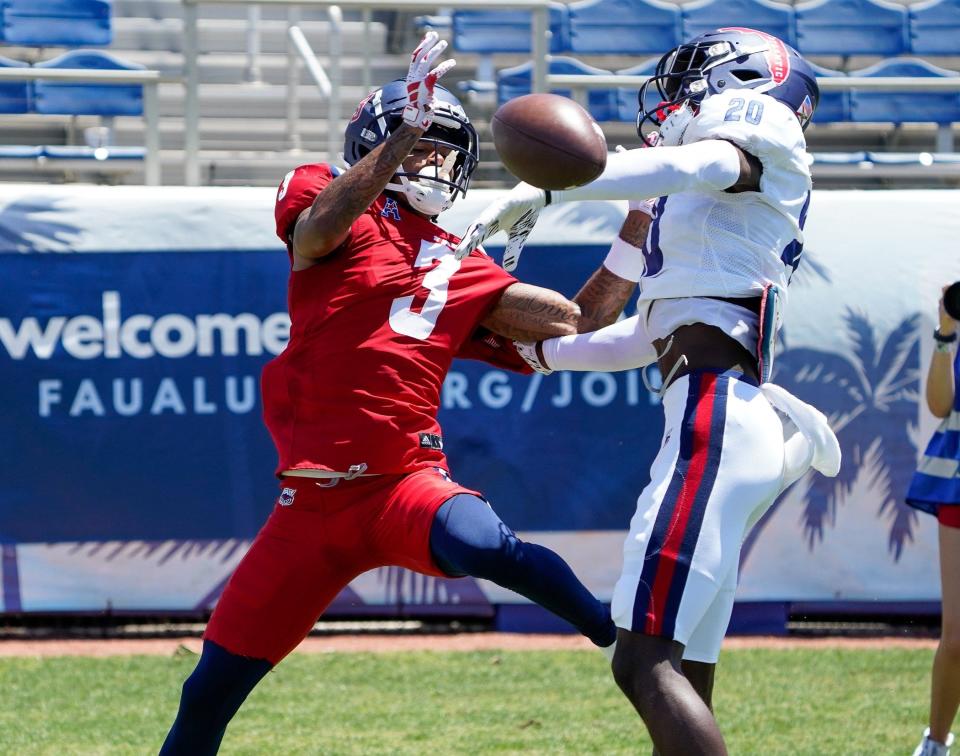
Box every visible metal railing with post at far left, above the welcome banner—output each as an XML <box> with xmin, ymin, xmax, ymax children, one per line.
<box><xmin>0</xmin><ymin>68</ymin><xmax>169</xmax><ymax>186</ymax></box>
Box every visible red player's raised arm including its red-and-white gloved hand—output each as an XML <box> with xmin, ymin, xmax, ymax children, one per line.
<box><xmin>293</xmin><ymin>32</ymin><xmax>456</xmax><ymax>260</ymax></box>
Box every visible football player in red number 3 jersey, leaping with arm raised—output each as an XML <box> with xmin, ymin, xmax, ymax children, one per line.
<box><xmin>162</xmin><ymin>33</ymin><xmax>646</xmax><ymax>756</ymax></box>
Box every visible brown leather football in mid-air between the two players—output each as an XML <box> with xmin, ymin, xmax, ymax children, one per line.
<box><xmin>490</xmin><ymin>94</ymin><xmax>607</xmax><ymax>189</ymax></box>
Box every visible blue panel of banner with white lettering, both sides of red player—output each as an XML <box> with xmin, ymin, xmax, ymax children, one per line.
<box><xmin>0</xmin><ymin>242</ymin><xmax>661</xmax><ymax>543</ymax></box>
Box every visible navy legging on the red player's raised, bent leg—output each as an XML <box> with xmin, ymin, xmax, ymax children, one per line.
<box><xmin>430</xmin><ymin>494</ymin><xmax>617</xmax><ymax>646</ymax></box>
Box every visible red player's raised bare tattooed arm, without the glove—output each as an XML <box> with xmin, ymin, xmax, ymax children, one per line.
<box><xmin>293</xmin><ymin>124</ymin><xmax>423</xmax><ymax>270</ymax></box>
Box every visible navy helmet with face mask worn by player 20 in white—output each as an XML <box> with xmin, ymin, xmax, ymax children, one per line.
<box><xmin>637</xmin><ymin>27</ymin><xmax>820</xmax><ymax>142</ymax></box>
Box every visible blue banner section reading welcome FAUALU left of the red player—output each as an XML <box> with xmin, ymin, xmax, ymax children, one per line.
<box><xmin>0</xmin><ymin>250</ymin><xmax>289</xmax><ymax>543</ymax></box>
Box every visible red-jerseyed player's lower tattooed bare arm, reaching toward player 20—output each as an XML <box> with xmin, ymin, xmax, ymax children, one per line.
<box><xmin>482</xmin><ymin>211</ymin><xmax>650</xmax><ymax>341</ymax></box>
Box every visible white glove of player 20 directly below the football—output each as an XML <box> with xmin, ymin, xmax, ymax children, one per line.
<box><xmin>454</xmin><ymin>183</ymin><xmax>547</xmax><ymax>270</ymax></box>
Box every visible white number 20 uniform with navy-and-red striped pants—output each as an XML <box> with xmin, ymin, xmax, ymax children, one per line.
<box><xmin>543</xmin><ymin>89</ymin><xmax>839</xmax><ymax>663</ymax></box>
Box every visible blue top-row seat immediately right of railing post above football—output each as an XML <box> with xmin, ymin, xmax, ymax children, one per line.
<box><xmin>569</xmin><ymin>0</ymin><xmax>683</xmax><ymax>55</ymax></box>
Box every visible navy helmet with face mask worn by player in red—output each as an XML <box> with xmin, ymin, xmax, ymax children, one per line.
<box><xmin>343</xmin><ymin>79</ymin><xmax>480</xmax><ymax>217</ymax></box>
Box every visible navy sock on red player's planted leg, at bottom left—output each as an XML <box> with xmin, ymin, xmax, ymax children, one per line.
<box><xmin>160</xmin><ymin>641</ymin><xmax>273</xmax><ymax>756</ymax></box>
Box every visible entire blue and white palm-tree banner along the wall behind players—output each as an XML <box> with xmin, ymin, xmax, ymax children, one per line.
<box><xmin>0</xmin><ymin>185</ymin><xmax>960</xmax><ymax>614</ymax></box>
